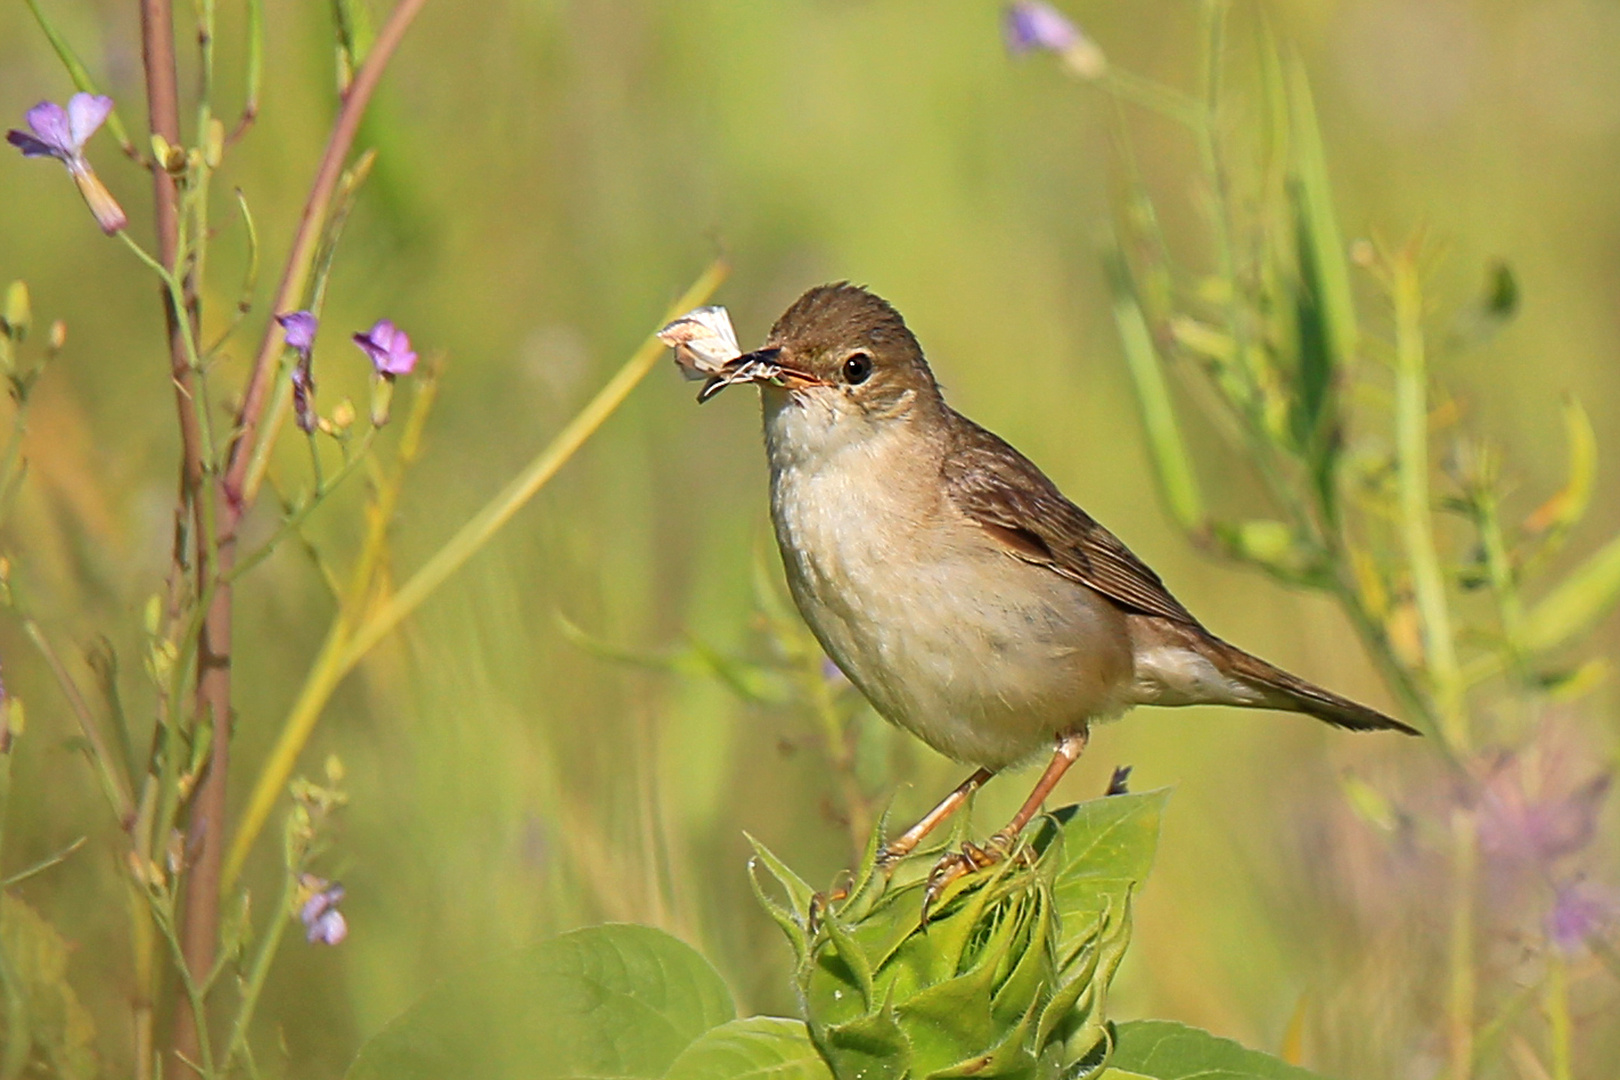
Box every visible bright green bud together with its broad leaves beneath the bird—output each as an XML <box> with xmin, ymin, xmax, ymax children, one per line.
<box><xmin>348</xmin><ymin>792</ymin><xmax>1328</xmax><ymax>1080</ymax></box>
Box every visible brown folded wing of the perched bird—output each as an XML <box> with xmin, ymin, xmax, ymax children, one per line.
<box><xmin>940</xmin><ymin>416</ymin><xmax>1199</xmax><ymax>627</ymax></box>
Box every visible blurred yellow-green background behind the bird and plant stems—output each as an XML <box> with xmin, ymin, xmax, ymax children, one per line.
<box><xmin>0</xmin><ymin>0</ymin><xmax>1620</xmax><ymax>1077</ymax></box>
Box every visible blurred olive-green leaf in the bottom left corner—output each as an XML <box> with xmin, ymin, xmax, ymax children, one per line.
<box><xmin>0</xmin><ymin>895</ymin><xmax>100</xmax><ymax>1080</ymax></box>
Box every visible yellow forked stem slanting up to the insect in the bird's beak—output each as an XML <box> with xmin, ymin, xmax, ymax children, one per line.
<box><xmin>225</xmin><ymin>262</ymin><xmax>727</xmax><ymax>887</ymax></box>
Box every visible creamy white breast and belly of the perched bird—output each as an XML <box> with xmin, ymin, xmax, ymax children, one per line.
<box><xmin>766</xmin><ymin>404</ymin><xmax>1131</xmax><ymax>767</ymax></box>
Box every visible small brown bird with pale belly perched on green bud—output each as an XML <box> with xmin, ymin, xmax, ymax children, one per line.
<box><xmin>698</xmin><ymin>283</ymin><xmax>1418</xmax><ymax>879</ymax></box>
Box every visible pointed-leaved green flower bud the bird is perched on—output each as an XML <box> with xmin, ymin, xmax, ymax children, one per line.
<box><xmin>755</xmin><ymin>792</ymin><xmax>1165</xmax><ymax>1080</ymax></box>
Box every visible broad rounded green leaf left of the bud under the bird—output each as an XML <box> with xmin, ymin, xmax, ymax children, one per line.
<box><xmin>348</xmin><ymin>923</ymin><xmax>735</xmax><ymax>1080</ymax></box>
